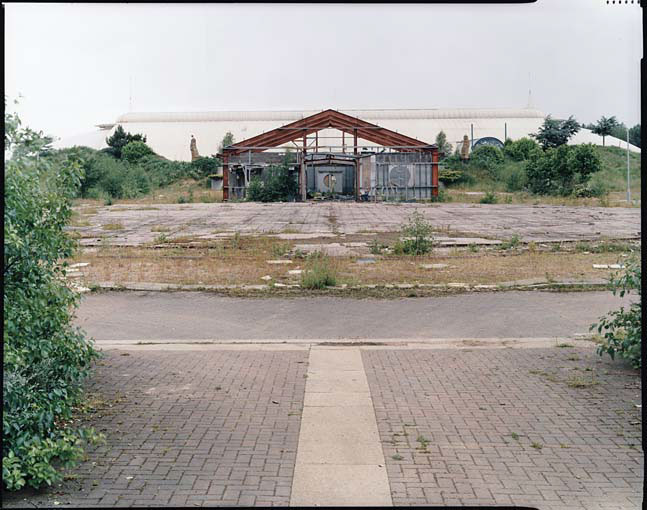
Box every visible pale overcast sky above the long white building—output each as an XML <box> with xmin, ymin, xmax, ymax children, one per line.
<box><xmin>4</xmin><ymin>0</ymin><xmax>642</xmax><ymax>136</ymax></box>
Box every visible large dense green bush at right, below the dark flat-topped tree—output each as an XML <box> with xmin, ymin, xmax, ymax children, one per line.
<box><xmin>525</xmin><ymin>144</ymin><xmax>601</xmax><ymax>196</ymax></box>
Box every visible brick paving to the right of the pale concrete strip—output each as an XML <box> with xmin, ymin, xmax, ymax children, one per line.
<box><xmin>363</xmin><ymin>348</ymin><xmax>642</xmax><ymax>510</ymax></box>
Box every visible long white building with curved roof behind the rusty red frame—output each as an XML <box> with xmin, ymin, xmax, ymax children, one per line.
<box><xmin>55</xmin><ymin>108</ymin><xmax>640</xmax><ymax>161</ymax></box>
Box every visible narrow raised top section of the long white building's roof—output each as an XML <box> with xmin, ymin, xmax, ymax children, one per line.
<box><xmin>116</xmin><ymin>108</ymin><xmax>545</xmax><ymax>124</ymax></box>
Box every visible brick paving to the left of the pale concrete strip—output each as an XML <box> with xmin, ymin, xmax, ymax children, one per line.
<box><xmin>4</xmin><ymin>351</ymin><xmax>308</xmax><ymax>507</ymax></box>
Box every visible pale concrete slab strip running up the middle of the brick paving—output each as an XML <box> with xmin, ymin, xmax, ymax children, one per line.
<box><xmin>290</xmin><ymin>346</ymin><xmax>393</xmax><ymax>506</ymax></box>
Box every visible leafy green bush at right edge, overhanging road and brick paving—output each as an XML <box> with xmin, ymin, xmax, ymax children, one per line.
<box><xmin>590</xmin><ymin>257</ymin><xmax>642</xmax><ymax>368</ymax></box>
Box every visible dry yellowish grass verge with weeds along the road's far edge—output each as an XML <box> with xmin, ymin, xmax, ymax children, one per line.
<box><xmin>67</xmin><ymin>237</ymin><xmax>635</xmax><ymax>290</ymax></box>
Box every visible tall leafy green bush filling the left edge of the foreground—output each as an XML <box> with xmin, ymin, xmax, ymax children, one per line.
<box><xmin>2</xmin><ymin>107</ymin><xmax>99</xmax><ymax>490</ymax></box>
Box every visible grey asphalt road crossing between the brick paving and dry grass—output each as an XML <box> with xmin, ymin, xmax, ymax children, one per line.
<box><xmin>76</xmin><ymin>292</ymin><xmax>629</xmax><ymax>342</ymax></box>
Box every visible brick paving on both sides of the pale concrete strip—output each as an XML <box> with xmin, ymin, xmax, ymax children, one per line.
<box><xmin>3</xmin><ymin>344</ymin><xmax>642</xmax><ymax>510</ymax></box>
